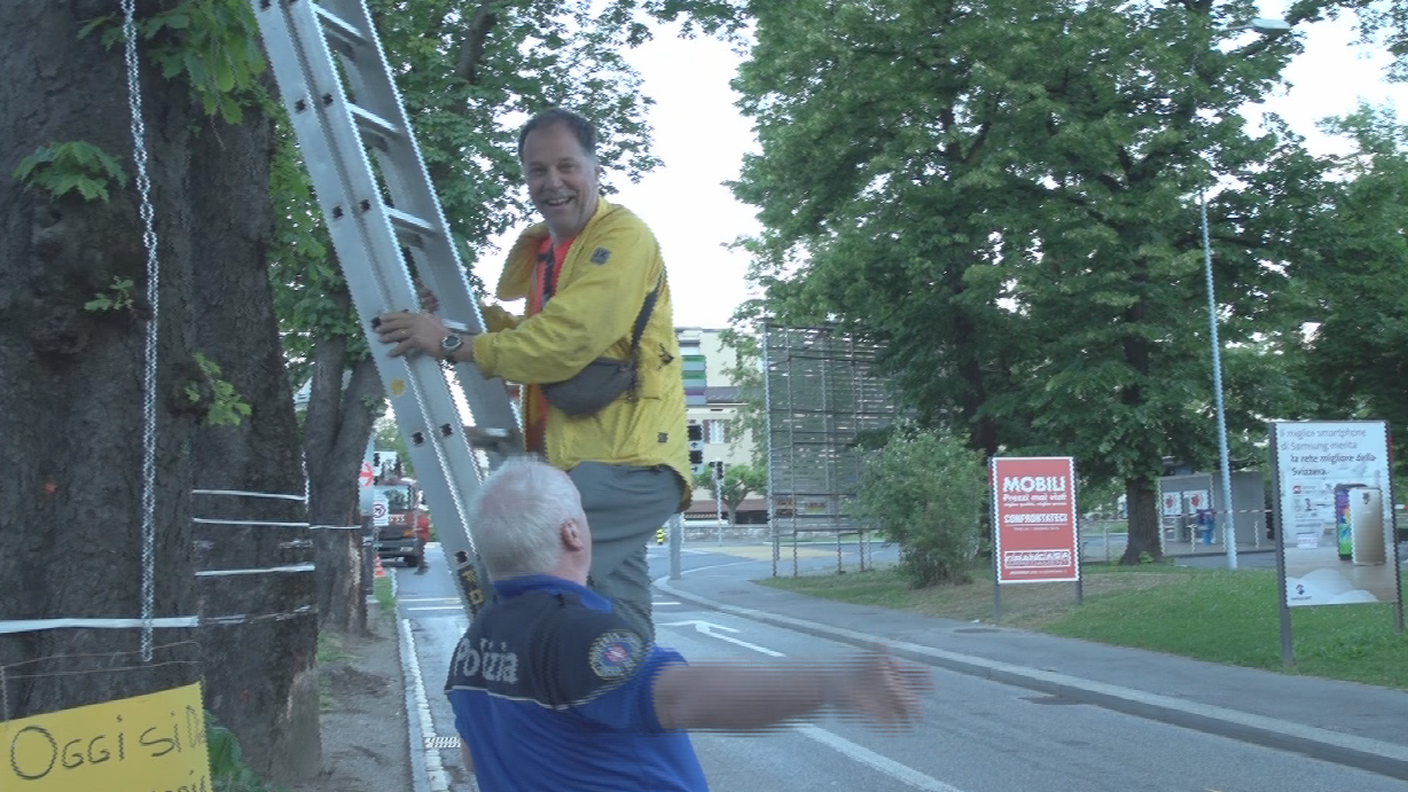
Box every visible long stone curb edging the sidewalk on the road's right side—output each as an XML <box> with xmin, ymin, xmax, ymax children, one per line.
<box><xmin>655</xmin><ymin>569</ymin><xmax>1408</xmax><ymax>779</ymax></box>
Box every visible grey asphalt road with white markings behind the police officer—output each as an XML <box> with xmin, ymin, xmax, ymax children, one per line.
<box><xmin>393</xmin><ymin>543</ymin><xmax>1402</xmax><ymax>792</ymax></box>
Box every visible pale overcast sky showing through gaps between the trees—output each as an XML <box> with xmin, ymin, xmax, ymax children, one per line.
<box><xmin>495</xmin><ymin>8</ymin><xmax>1408</xmax><ymax>327</ymax></box>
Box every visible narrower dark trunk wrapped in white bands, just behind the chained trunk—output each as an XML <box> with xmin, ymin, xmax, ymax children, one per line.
<box><xmin>190</xmin><ymin>97</ymin><xmax>322</xmax><ymax>784</ymax></box>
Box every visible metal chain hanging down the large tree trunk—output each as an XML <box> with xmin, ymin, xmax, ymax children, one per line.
<box><xmin>122</xmin><ymin>0</ymin><xmax>161</xmax><ymax>662</ymax></box>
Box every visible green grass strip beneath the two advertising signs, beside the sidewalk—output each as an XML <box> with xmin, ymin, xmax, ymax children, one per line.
<box><xmin>758</xmin><ymin>564</ymin><xmax>1408</xmax><ymax>689</ymax></box>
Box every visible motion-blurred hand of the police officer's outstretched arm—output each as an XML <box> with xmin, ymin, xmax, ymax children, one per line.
<box><xmin>831</xmin><ymin>650</ymin><xmax>934</xmax><ymax>729</ymax></box>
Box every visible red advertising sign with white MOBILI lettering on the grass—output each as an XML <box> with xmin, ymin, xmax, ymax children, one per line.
<box><xmin>993</xmin><ymin>457</ymin><xmax>1080</xmax><ymax>583</ymax></box>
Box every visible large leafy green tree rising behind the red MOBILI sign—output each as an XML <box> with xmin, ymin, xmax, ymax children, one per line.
<box><xmin>736</xmin><ymin>0</ymin><xmax>1351</xmax><ymax>562</ymax></box>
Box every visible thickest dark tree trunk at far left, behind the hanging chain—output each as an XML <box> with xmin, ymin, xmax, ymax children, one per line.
<box><xmin>0</xmin><ymin>0</ymin><xmax>199</xmax><ymax>719</ymax></box>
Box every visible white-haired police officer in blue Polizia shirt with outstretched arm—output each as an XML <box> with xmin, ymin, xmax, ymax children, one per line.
<box><xmin>445</xmin><ymin>459</ymin><xmax>928</xmax><ymax>792</ymax></box>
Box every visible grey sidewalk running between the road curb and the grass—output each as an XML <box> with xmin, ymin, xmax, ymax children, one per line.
<box><xmin>655</xmin><ymin>569</ymin><xmax>1408</xmax><ymax>779</ymax></box>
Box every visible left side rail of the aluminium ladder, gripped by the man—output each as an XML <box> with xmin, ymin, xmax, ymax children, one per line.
<box><xmin>255</xmin><ymin>0</ymin><xmax>490</xmax><ymax>613</ymax></box>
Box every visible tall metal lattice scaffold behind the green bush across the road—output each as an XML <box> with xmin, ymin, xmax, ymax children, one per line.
<box><xmin>762</xmin><ymin>324</ymin><xmax>903</xmax><ymax>575</ymax></box>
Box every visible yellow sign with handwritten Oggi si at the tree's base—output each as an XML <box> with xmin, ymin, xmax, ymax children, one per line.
<box><xmin>0</xmin><ymin>682</ymin><xmax>211</xmax><ymax>792</ymax></box>
